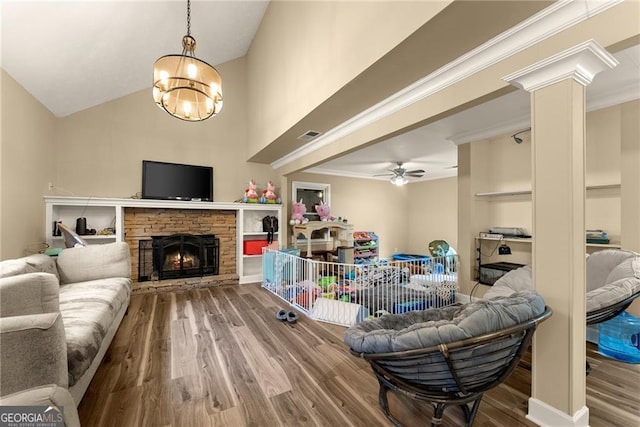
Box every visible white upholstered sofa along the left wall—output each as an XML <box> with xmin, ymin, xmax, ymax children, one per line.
<box><xmin>0</xmin><ymin>243</ymin><xmax>132</xmax><ymax>425</ymax></box>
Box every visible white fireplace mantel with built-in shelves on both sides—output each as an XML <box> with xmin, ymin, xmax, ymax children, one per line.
<box><xmin>44</xmin><ymin>196</ymin><xmax>282</xmax><ymax>283</ymax></box>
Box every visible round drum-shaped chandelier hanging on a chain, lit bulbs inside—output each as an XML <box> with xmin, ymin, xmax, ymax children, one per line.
<box><xmin>153</xmin><ymin>0</ymin><xmax>222</xmax><ymax>122</ymax></box>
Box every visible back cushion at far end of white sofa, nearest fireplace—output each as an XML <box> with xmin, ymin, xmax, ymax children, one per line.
<box><xmin>58</xmin><ymin>242</ymin><xmax>131</xmax><ymax>284</ymax></box>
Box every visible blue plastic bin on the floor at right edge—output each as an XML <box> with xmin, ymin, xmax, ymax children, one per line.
<box><xmin>598</xmin><ymin>311</ymin><xmax>640</xmax><ymax>363</ymax></box>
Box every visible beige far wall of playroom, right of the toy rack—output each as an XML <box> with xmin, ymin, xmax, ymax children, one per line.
<box><xmin>408</xmin><ymin>177</ymin><xmax>458</xmax><ymax>254</ymax></box>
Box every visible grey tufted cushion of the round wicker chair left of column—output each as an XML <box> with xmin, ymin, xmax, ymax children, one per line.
<box><xmin>344</xmin><ymin>290</ymin><xmax>545</xmax><ymax>353</ymax></box>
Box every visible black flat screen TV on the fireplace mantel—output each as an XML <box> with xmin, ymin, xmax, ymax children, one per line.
<box><xmin>142</xmin><ymin>160</ymin><xmax>213</xmax><ymax>202</ymax></box>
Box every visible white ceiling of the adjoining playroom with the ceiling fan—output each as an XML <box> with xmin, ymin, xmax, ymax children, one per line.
<box><xmin>305</xmin><ymin>45</ymin><xmax>640</xmax><ymax>182</ymax></box>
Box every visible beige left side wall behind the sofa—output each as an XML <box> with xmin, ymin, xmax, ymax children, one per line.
<box><xmin>0</xmin><ymin>70</ymin><xmax>55</xmax><ymax>259</ymax></box>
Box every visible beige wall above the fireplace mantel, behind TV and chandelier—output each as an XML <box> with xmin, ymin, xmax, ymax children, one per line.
<box><xmin>54</xmin><ymin>58</ymin><xmax>279</xmax><ymax>202</ymax></box>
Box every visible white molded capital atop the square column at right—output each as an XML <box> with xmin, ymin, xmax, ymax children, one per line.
<box><xmin>502</xmin><ymin>40</ymin><xmax>618</xmax><ymax>92</ymax></box>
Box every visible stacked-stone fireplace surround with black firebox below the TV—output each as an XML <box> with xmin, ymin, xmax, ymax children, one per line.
<box><xmin>124</xmin><ymin>207</ymin><xmax>238</xmax><ymax>290</ymax></box>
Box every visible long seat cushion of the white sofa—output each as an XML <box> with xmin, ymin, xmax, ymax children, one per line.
<box><xmin>60</xmin><ymin>278</ymin><xmax>131</xmax><ymax>387</ymax></box>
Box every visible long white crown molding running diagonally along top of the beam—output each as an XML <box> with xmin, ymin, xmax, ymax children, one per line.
<box><xmin>271</xmin><ymin>0</ymin><xmax>622</xmax><ymax>169</ymax></box>
